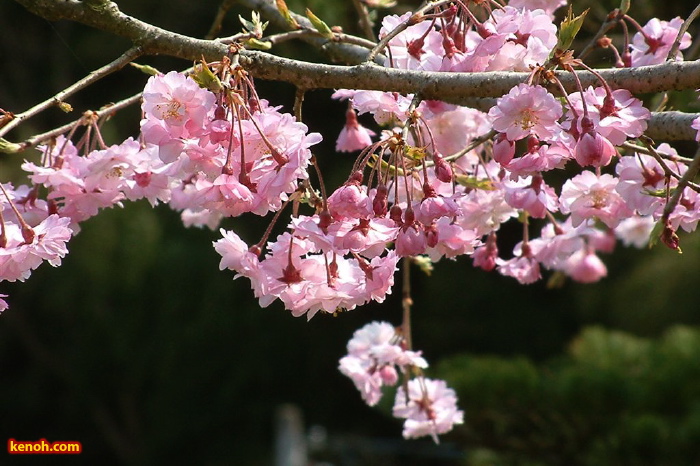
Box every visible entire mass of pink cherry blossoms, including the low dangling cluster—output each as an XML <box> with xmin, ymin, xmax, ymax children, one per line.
<box><xmin>8</xmin><ymin>0</ymin><xmax>700</xmax><ymax>441</ymax></box>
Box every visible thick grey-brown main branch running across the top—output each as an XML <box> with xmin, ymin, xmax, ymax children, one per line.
<box><xmin>8</xmin><ymin>0</ymin><xmax>700</xmax><ymax>139</ymax></box>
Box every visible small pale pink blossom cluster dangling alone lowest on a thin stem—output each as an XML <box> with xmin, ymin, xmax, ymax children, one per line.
<box><xmin>339</xmin><ymin>322</ymin><xmax>464</xmax><ymax>442</ymax></box>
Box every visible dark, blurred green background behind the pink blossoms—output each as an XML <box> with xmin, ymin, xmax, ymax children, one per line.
<box><xmin>0</xmin><ymin>0</ymin><xmax>700</xmax><ymax>465</ymax></box>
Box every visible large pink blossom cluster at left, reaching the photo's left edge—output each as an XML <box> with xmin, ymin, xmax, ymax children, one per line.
<box><xmin>6</xmin><ymin>65</ymin><xmax>320</xmax><ymax>307</ymax></box>
